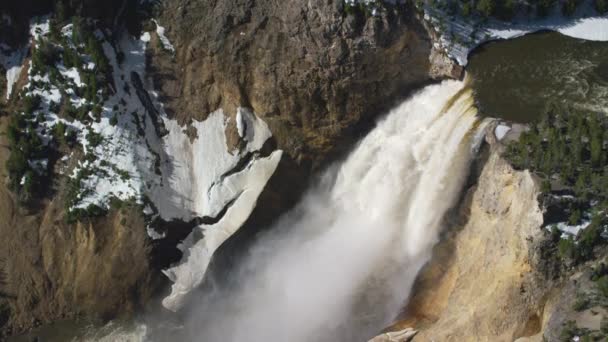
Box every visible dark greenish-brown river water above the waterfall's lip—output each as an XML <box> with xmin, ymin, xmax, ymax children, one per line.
<box><xmin>467</xmin><ymin>32</ymin><xmax>608</xmax><ymax>123</ymax></box>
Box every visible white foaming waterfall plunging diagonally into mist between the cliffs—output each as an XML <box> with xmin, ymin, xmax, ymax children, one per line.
<box><xmin>89</xmin><ymin>81</ymin><xmax>487</xmax><ymax>342</ymax></box>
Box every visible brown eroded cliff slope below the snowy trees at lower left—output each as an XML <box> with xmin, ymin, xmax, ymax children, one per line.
<box><xmin>0</xmin><ymin>118</ymin><xmax>159</xmax><ymax>339</ymax></box>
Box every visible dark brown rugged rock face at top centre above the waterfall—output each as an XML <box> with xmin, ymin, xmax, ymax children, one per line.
<box><xmin>151</xmin><ymin>0</ymin><xmax>442</xmax><ymax>170</ymax></box>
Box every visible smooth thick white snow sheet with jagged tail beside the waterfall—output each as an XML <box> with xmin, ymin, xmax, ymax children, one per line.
<box><xmin>156</xmin><ymin>108</ymin><xmax>282</xmax><ymax>311</ymax></box>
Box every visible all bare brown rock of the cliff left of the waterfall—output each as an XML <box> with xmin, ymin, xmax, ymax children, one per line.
<box><xmin>0</xmin><ymin>0</ymin><xmax>460</xmax><ymax>333</ymax></box>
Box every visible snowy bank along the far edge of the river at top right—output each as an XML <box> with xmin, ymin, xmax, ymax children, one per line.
<box><xmin>424</xmin><ymin>0</ymin><xmax>608</xmax><ymax>66</ymax></box>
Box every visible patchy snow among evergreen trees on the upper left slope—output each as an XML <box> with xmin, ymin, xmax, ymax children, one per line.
<box><xmin>16</xmin><ymin>18</ymin><xmax>158</xmax><ymax>211</ymax></box>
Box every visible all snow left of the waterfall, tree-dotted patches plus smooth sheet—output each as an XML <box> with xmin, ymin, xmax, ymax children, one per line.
<box><xmin>16</xmin><ymin>18</ymin><xmax>282</xmax><ymax>310</ymax></box>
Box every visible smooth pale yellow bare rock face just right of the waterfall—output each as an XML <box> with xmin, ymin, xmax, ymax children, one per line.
<box><xmin>399</xmin><ymin>130</ymin><xmax>554</xmax><ymax>341</ymax></box>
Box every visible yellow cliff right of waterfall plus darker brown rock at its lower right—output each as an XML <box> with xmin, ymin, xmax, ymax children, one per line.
<box><xmin>390</xmin><ymin>126</ymin><xmax>606</xmax><ymax>342</ymax></box>
